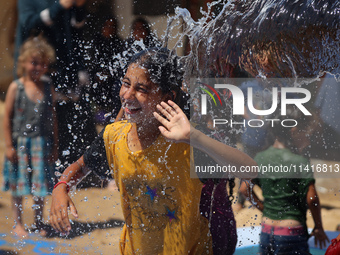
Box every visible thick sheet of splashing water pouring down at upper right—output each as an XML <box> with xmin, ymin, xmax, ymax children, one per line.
<box><xmin>169</xmin><ymin>0</ymin><xmax>340</xmax><ymax>79</ymax></box>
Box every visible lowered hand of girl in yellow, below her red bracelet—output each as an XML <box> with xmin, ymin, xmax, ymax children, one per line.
<box><xmin>49</xmin><ymin>184</ymin><xmax>78</xmax><ymax>234</ymax></box>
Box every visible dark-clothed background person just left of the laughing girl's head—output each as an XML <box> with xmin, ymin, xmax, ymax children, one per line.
<box><xmin>90</xmin><ymin>15</ymin><xmax>123</xmax><ymax>124</ymax></box>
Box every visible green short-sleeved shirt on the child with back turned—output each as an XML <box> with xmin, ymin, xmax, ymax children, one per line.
<box><xmin>253</xmin><ymin>147</ymin><xmax>315</xmax><ymax>225</ymax></box>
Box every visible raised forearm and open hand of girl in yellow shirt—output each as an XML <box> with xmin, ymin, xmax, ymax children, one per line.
<box><xmin>154</xmin><ymin>100</ymin><xmax>257</xmax><ymax>178</ymax></box>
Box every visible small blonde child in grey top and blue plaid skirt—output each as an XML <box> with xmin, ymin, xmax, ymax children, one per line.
<box><xmin>4</xmin><ymin>36</ymin><xmax>58</xmax><ymax>238</ymax></box>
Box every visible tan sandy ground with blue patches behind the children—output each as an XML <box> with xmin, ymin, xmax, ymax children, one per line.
<box><xmin>0</xmin><ymin>102</ymin><xmax>340</xmax><ymax>255</ymax></box>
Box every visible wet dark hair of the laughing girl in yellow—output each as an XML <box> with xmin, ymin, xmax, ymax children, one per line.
<box><xmin>128</xmin><ymin>47</ymin><xmax>188</xmax><ymax>112</ymax></box>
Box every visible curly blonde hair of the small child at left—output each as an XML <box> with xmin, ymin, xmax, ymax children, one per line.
<box><xmin>17</xmin><ymin>35</ymin><xmax>55</xmax><ymax>76</ymax></box>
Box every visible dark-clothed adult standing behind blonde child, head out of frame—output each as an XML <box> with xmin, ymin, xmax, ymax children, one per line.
<box><xmin>16</xmin><ymin>0</ymin><xmax>96</xmax><ymax>165</ymax></box>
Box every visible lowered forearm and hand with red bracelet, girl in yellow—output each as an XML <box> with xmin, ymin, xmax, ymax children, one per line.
<box><xmin>49</xmin><ymin>156</ymin><xmax>85</xmax><ymax>234</ymax></box>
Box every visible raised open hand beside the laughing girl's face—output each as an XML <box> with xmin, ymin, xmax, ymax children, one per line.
<box><xmin>154</xmin><ymin>100</ymin><xmax>192</xmax><ymax>143</ymax></box>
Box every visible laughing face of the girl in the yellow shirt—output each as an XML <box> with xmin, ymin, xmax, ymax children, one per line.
<box><xmin>119</xmin><ymin>63</ymin><xmax>170</xmax><ymax>125</ymax></box>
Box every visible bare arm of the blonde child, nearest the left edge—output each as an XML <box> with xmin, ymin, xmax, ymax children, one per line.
<box><xmin>4</xmin><ymin>82</ymin><xmax>18</xmax><ymax>163</ymax></box>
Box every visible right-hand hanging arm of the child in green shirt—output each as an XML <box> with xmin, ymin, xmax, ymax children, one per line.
<box><xmin>307</xmin><ymin>183</ymin><xmax>329</xmax><ymax>249</ymax></box>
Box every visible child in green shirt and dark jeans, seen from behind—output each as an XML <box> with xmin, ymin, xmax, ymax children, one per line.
<box><xmin>240</xmin><ymin>106</ymin><xmax>329</xmax><ymax>255</ymax></box>
